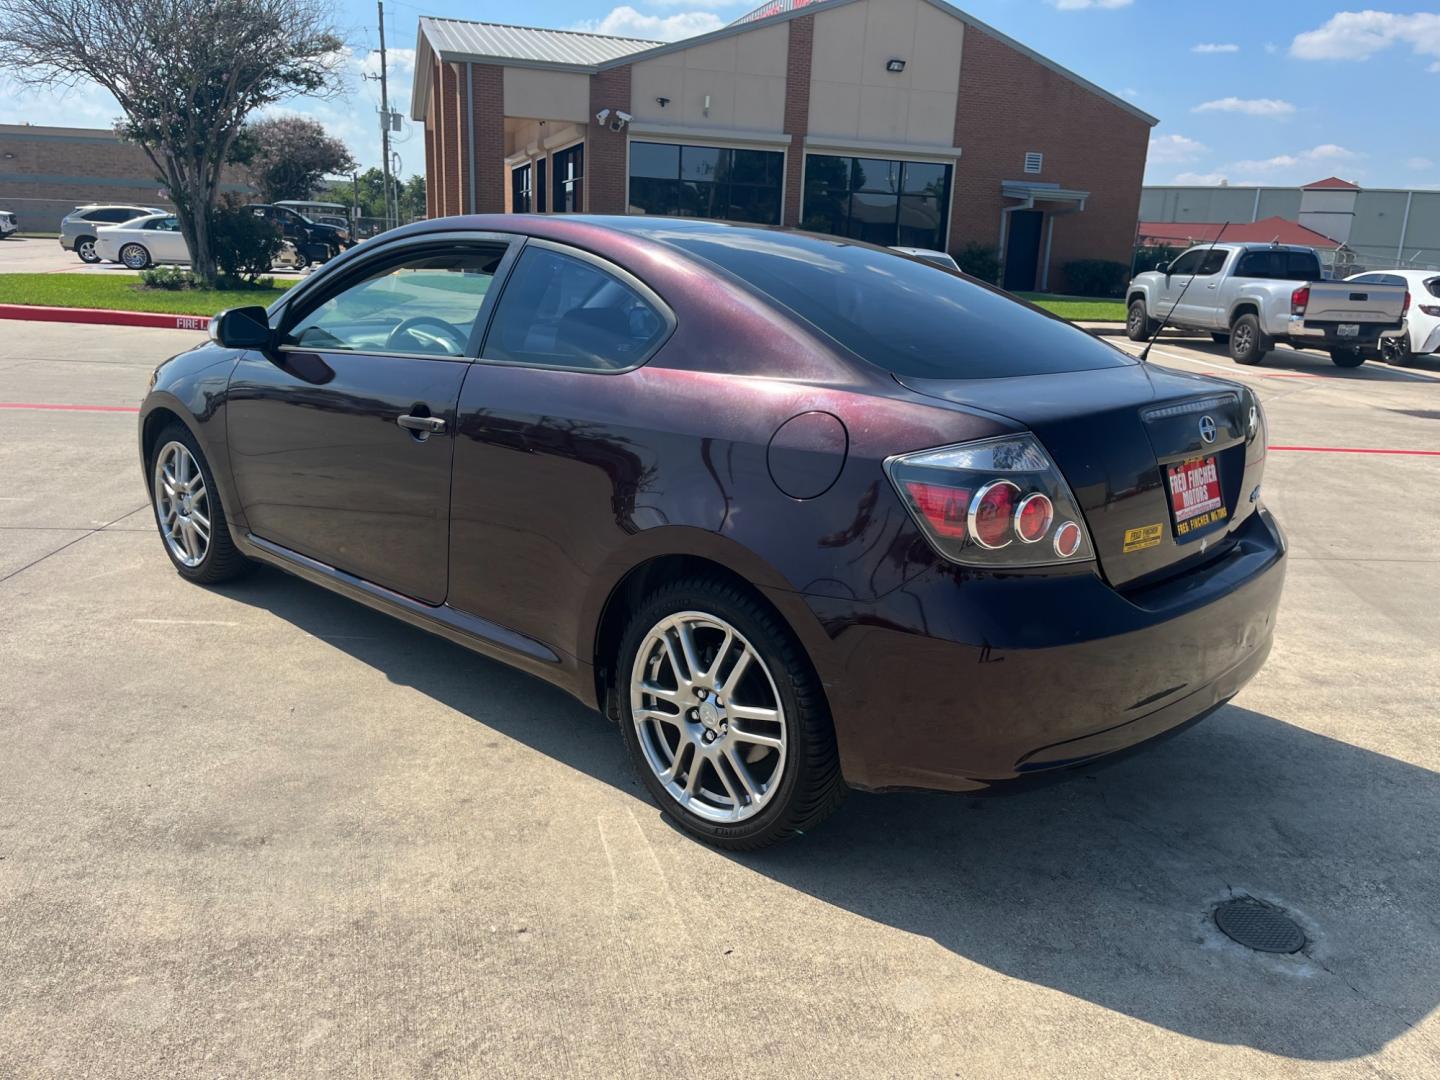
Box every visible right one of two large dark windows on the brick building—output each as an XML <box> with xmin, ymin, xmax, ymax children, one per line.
<box><xmin>801</xmin><ymin>154</ymin><xmax>952</xmax><ymax>251</ymax></box>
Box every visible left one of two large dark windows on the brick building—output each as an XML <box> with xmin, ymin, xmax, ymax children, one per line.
<box><xmin>629</xmin><ymin>143</ymin><xmax>785</xmax><ymax>225</ymax></box>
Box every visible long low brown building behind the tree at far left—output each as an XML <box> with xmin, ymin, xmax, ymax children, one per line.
<box><xmin>0</xmin><ymin>124</ymin><xmax>251</xmax><ymax>232</ymax></box>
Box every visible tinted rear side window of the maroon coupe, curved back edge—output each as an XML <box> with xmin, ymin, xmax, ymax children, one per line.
<box><xmin>482</xmin><ymin>246</ymin><xmax>668</xmax><ymax>372</ymax></box>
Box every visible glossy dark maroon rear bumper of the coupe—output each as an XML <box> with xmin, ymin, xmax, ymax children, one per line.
<box><xmin>806</xmin><ymin>511</ymin><xmax>1284</xmax><ymax>791</ymax></box>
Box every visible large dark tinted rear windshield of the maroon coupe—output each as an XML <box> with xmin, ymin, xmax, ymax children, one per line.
<box><xmin>628</xmin><ymin>222</ymin><xmax>1135</xmax><ymax>379</ymax></box>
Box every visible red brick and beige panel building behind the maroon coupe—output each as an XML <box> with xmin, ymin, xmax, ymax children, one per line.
<box><xmin>412</xmin><ymin>0</ymin><xmax>1156</xmax><ymax>291</ymax></box>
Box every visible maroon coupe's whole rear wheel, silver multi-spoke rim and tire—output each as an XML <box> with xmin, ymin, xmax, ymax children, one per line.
<box><xmin>616</xmin><ymin>577</ymin><xmax>845</xmax><ymax>851</ymax></box>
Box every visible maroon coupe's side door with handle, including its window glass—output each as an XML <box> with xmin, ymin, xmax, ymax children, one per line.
<box><xmin>226</xmin><ymin>233</ymin><xmax>511</xmax><ymax>605</ymax></box>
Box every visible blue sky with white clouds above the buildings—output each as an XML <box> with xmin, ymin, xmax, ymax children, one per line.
<box><xmin>0</xmin><ymin>0</ymin><xmax>1440</xmax><ymax>187</ymax></box>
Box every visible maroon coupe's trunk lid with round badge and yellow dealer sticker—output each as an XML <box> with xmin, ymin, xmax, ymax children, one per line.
<box><xmin>896</xmin><ymin>363</ymin><xmax>1264</xmax><ymax>586</ymax></box>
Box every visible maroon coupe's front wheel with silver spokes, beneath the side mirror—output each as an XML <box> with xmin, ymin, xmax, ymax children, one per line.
<box><xmin>150</xmin><ymin>423</ymin><xmax>251</xmax><ymax>585</ymax></box>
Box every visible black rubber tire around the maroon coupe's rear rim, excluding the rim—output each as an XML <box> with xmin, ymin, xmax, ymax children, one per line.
<box><xmin>615</xmin><ymin>577</ymin><xmax>847</xmax><ymax>851</ymax></box>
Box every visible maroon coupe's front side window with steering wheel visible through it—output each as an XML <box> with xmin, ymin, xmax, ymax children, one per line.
<box><xmin>285</xmin><ymin>245</ymin><xmax>504</xmax><ymax>357</ymax></box>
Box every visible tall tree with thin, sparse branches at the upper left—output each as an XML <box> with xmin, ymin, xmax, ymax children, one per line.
<box><xmin>0</xmin><ymin>0</ymin><xmax>344</xmax><ymax>284</ymax></box>
